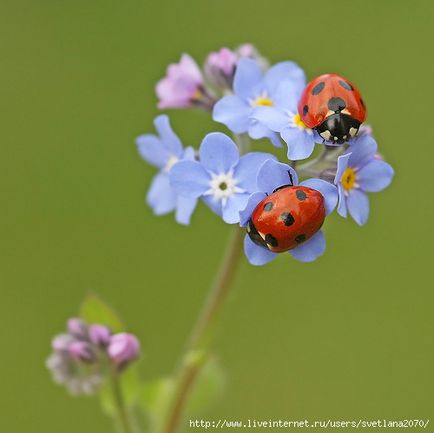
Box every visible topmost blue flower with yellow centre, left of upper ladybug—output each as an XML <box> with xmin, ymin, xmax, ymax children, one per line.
<box><xmin>213</xmin><ymin>59</ymin><xmax>306</xmax><ymax>147</ymax></box>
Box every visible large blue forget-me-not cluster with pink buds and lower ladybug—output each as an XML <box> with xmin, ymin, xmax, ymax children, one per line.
<box><xmin>137</xmin><ymin>44</ymin><xmax>394</xmax><ymax>265</ymax></box>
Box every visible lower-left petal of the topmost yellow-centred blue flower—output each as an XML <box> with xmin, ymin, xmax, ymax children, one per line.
<box><xmin>212</xmin><ymin>95</ymin><xmax>252</xmax><ymax>134</ymax></box>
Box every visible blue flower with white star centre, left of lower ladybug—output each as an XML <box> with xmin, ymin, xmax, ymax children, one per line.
<box><xmin>170</xmin><ymin>132</ymin><xmax>274</xmax><ymax>224</ymax></box>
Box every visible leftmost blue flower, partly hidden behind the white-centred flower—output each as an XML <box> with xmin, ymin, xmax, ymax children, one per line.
<box><xmin>136</xmin><ymin>115</ymin><xmax>197</xmax><ymax>224</ymax></box>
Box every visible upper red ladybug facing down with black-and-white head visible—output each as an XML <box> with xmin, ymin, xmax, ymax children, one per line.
<box><xmin>298</xmin><ymin>74</ymin><xmax>366</xmax><ymax>144</ymax></box>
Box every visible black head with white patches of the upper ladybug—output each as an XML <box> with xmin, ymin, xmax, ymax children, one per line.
<box><xmin>316</xmin><ymin>112</ymin><xmax>360</xmax><ymax>144</ymax></box>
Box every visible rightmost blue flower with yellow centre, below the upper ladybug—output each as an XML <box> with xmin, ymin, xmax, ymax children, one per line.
<box><xmin>335</xmin><ymin>135</ymin><xmax>394</xmax><ymax>225</ymax></box>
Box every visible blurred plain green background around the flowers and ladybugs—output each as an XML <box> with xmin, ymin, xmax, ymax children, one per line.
<box><xmin>0</xmin><ymin>0</ymin><xmax>434</xmax><ymax>433</ymax></box>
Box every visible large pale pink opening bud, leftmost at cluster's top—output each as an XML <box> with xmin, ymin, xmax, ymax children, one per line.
<box><xmin>155</xmin><ymin>54</ymin><xmax>212</xmax><ymax>108</ymax></box>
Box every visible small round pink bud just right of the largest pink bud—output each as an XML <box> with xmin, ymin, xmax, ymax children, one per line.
<box><xmin>204</xmin><ymin>48</ymin><xmax>237</xmax><ymax>88</ymax></box>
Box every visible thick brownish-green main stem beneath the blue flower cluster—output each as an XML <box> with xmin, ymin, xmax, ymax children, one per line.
<box><xmin>164</xmin><ymin>227</ymin><xmax>244</xmax><ymax>433</ymax></box>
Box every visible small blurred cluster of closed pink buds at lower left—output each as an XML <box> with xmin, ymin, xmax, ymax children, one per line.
<box><xmin>46</xmin><ymin>318</ymin><xmax>140</xmax><ymax>395</ymax></box>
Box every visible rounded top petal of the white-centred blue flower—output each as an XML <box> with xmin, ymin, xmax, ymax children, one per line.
<box><xmin>199</xmin><ymin>132</ymin><xmax>240</xmax><ymax>174</ymax></box>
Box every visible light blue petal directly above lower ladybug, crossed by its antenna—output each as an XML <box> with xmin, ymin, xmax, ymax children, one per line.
<box><xmin>257</xmin><ymin>159</ymin><xmax>298</xmax><ymax>194</ymax></box>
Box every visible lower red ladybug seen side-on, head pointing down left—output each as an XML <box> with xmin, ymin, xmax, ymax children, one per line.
<box><xmin>247</xmin><ymin>185</ymin><xmax>325</xmax><ymax>253</ymax></box>
